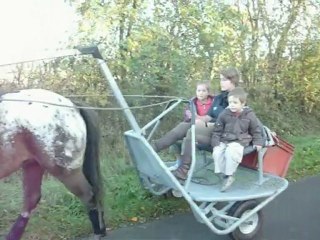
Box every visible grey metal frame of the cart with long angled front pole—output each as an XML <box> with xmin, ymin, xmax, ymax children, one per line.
<box><xmin>89</xmin><ymin>46</ymin><xmax>288</xmax><ymax>235</ymax></box>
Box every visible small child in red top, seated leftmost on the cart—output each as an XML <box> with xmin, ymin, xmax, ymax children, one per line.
<box><xmin>170</xmin><ymin>82</ymin><xmax>213</xmax><ymax>170</ymax></box>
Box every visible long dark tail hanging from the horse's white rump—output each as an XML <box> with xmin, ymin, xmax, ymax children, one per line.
<box><xmin>77</xmin><ymin>103</ymin><xmax>103</xmax><ymax>209</ymax></box>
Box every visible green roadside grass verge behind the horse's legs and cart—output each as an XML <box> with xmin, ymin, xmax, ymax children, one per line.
<box><xmin>0</xmin><ymin>136</ymin><xmax>320</xmax><ymax>240</ymax></box>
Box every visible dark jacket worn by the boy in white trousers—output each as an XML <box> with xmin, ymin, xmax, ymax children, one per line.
<box><xmin>211</xmin><ymin>107</ymin><xmax>264</xmax><ymax>147</ymax></box>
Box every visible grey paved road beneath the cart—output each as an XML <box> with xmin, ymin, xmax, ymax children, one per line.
<box><xmin>80</xmin><ymin>176</ymin><xmax>320</xmax><ymax>240</ymax></box>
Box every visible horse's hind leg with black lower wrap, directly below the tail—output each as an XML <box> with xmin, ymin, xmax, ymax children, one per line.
<box><xmin>55</xmin><ymin>169</ymin><xmax>106</xmax><ymax>239</ymax></box>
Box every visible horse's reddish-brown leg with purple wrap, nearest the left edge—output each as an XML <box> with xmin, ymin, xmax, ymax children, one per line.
<box><xmin>6</xmin><ymin>161</ymin><xmax>44</xmax><ymax>240</ymax></box>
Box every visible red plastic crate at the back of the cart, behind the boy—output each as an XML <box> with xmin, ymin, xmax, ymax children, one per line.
<box><xmin>241</xmin><ymin>137</ymin><xmax>294</xmax><ymax>177</ymax></box>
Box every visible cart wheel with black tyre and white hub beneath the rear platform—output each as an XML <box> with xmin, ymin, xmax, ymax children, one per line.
<box><xmin>229</xmin><ymin>200</ymin><xmax>263</xmax><ymax>240</ymax></box>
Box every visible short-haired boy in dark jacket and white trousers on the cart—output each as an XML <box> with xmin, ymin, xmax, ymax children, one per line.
<box><xmin>211</xmin><ymin>87</ymin><xmax>263</xmax><ymax>192</ymax></box>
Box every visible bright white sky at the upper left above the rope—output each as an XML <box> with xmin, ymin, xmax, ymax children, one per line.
<box><xmin>0</xmin><ymin>0</ymin><xmax>77</xmax><ymax>64</ymax></box>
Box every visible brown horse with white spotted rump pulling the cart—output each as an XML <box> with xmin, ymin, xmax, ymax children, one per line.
<box><xmin>0</xmin><ymin>89</ymin><xmax>106</xmax><ymax>240</ymax></box>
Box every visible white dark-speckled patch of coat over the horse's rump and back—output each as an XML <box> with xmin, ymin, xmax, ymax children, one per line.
<box><xmin>0</xmin><ymin>89</ymin><xmax>86</xmax><ymax>169</ymax></box>
